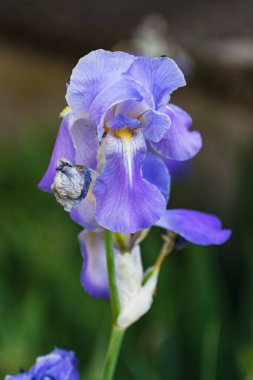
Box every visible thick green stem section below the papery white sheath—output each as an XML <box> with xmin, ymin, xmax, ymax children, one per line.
<box><xmin>102</xmin><ymin>326</ymin><xmax>125</xmax><ymax>380</ymax></box>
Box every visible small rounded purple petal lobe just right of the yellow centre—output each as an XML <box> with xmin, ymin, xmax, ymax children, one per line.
<box><xmin>141</xmin><ymin>110</ymin><xmax>171</xmax><ymax>142</ymax></box>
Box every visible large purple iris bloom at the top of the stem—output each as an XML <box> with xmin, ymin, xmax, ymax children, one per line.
<box><xmin>39</xmin><ymin>50</ymin><xmax>202</xmax><ymax>233</ymax></box>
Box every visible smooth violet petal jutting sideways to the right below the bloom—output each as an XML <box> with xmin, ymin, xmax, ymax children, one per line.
<box><xmin>155</xmin><ymin>210</ymin><xmax>231</xmax><ymax>245</ymax></box>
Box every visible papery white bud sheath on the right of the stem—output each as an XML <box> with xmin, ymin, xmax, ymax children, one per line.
<box><xmin>115</xmin><ymin>246</ymin><xmax>158</xmax><ymax>328</ymax></box>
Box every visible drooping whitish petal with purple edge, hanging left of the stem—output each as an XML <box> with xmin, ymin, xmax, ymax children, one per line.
<box><xmin>78</xmin><ymin>230</ymin><xmax>109</xmax><ymax>298</ymax></box>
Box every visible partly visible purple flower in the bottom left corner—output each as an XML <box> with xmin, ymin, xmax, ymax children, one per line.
<box><xmin>5</xmin><ymin>348</ymin><xmax>79</xmax><ymax>380</ymax></box>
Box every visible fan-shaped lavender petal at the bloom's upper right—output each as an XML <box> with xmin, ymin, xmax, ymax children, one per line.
<box><xmin>123</xmin><ymin>57</ymin><xmax>186</xmax><ymax>110</ymax></box>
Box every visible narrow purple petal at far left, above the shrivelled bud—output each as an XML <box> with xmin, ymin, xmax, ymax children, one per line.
<box><xmin>38</xmin><ymin>116</ymin><xmax>76</xmax><ymax>193</ymax></box>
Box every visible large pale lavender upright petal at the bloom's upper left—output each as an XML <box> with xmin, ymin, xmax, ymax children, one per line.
<box><xmin>66</xmin><ymin>50</ymin><xmax>142</xmax><ymax>139</ymax></box>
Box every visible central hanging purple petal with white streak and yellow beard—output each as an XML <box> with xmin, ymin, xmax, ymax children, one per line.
<box><xmin>93</xmin><ymin>130</ymin><xmax>166</xmax><ymax>233</ymax></box>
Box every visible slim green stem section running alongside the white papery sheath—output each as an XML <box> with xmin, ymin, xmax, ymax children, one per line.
<box><xmin>105</xmin><ymin>230</ymin><xmax>120</xmax><ymax>324</ymax></box>
